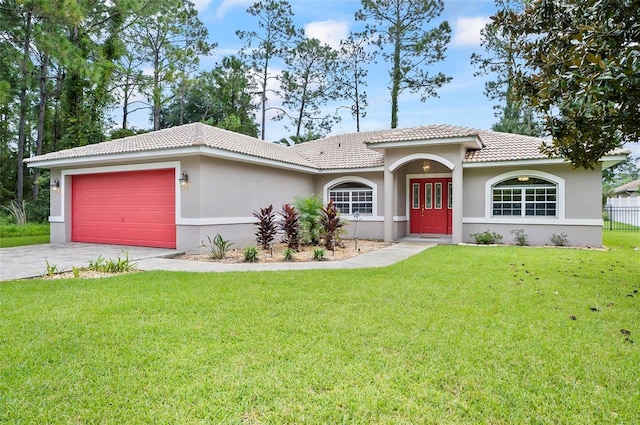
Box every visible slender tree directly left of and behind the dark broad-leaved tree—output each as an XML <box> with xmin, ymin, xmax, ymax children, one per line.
<box><xmin>471</xmin><ymin>0</ymin><xmax>542</xmax><ymax>136</ymax></box>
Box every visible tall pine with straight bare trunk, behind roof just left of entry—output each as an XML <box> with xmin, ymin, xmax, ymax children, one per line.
<box><xmin>356</xmin><ymin>0</ymin><xmax>451</xmax><ymax>128</ymax></box>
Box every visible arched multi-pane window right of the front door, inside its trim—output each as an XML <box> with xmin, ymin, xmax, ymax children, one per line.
<box><xmin>491</xmin><ymin>176</ymin><xmax>558</xmax><ymax>217</ymax></box>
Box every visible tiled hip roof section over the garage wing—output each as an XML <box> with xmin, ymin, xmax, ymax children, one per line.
<box><xmin>25</xmin><ymin>123</ymin><xmax>316</xmax><ymax>168</ymax></box>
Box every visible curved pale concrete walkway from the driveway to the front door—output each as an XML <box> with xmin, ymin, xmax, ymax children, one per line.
<box><xmin>136</xmin><ymin>241</ymin><xmax>437</xmax><ymax>273</ymax></box>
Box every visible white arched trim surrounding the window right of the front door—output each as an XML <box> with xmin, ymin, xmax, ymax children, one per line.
<box><xmin>485</xmin><ymin>170</ymin><xmax>565</xmax><ymax>224</ymax></box>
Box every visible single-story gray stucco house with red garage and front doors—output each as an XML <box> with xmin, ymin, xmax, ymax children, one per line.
<box><xmin>26</xmin><ymin>123</ymin><xmax>626</xmax><ymax>251</ymax></box>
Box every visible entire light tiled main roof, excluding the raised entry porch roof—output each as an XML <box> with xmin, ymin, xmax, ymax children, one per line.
<box><xmin>25</xmin><ymin>123</ymin><xmax>627</xmax><ymax>170</ymax></box>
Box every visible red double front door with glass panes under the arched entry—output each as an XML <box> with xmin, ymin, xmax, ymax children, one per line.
<box><xmin>409</xmin><ymin>177</ymin><xmax>452</xmax><ymax>235</ymax></box>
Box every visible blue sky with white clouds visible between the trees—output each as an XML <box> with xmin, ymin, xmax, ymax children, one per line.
<box><xmin>121</xmin><ymin>0</ymin><xmax>640</xmax><ymax>155</ymax></box>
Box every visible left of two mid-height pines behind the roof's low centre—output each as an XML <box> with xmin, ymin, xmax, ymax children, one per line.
<box><xmin>276</xmin><ymin>38</ymin><xmax>340</xmax><ymax>137</ymax></box>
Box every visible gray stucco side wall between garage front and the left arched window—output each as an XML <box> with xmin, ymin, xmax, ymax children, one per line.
<box><xmin>176</xmin><ymin>157</ymin><xmax>314</xmax><ymax>251</ymax></box>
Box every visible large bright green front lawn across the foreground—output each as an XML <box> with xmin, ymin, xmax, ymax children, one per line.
<box><xmin>0</xmin><ymin>232</ymin><xmax>640</xmax><ymax>424</ymax></box>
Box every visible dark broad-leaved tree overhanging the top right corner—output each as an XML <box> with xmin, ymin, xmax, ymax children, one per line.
<box><xmin>492</xmin><ymin>0</ymin><xmax>640</xmax><ymax>169</ymax></box>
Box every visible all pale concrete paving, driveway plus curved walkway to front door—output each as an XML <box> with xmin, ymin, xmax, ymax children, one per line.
<box><xmin>0</xmin><ymin>240</ymin><xmax>438</xmax><ymax>281</ymax></box>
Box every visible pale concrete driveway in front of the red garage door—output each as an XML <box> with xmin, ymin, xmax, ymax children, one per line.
<box><xmin>0</xmin><ymin>243</ymin><xmax>181</xmax><ymax>281</ymax></box>
